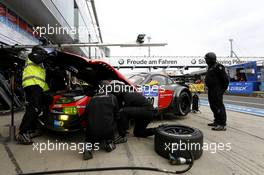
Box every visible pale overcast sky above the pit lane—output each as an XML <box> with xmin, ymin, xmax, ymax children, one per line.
<box><xmin>95</xmin><ymin>0</ymin><xmax>264</xmax><ymax>56</ymax></box>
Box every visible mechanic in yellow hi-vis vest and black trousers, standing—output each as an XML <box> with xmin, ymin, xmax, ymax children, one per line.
<box><xmin>17</xmin><ymin>46</ymin><xmax>49</xmax><ymax>144</ymax></box>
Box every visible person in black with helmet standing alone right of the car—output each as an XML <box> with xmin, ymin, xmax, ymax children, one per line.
<box><xmin>204</xmin><ymin>52</ymin><xmax>229</xmax><ymax>131</ymax></box>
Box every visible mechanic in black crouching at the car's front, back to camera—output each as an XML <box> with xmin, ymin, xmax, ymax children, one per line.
<box><xmin>83</xmin><ymin>81</ymin><xmax>119</xmax><ymax>160</ymax></box>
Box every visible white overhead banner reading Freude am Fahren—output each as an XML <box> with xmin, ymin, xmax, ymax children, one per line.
<box><xmin>106</xmin><ymin>56</ymin><xmax>264</xmax><ymax>67</ymax></box>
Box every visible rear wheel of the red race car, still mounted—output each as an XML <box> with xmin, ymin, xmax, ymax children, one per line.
<box><xmin>178</xmin><ymin>91</ymin><xmax>191</xmax><ymax>116</ymax></box>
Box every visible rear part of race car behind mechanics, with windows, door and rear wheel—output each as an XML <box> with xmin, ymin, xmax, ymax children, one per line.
<box><xmin>128</xmin><ymin>72</ymin><xmax>192</xmax><ymax>116</ymax></box>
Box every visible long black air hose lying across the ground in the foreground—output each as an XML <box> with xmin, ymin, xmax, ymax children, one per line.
<box><xmin>19</xmin><ymin>151</ymin><xmax>194</xmax><ymax>175</ymax></box>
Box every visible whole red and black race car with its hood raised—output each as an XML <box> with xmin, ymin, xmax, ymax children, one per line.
<box><xmin>41</xmin><ymin>51</ymin><xmax>191</xmax><ymax>131</ymax></box>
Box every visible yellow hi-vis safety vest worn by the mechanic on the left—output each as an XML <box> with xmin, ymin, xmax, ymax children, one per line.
<box><xmin>22</xmin><ymin>58</ymin><xmax>49</xmax><ymax>91</ymax></box>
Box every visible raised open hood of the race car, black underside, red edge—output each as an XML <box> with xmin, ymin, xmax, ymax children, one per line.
<box><xmin>48</xmin><ymin>51</ymin><xmax>130</xmax><ymax>84</ymax></box>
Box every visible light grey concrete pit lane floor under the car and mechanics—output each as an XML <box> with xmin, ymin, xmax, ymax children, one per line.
<box><xmin>0</xmin><ymin>106</ymin><xmax>264</xmax><ymax>175</ymax></box>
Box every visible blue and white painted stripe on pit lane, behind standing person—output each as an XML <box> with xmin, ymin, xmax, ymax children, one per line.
<box><xmin>200</xmin><ymin>100</ymin><xmax>264</xmax><ymax>117</ymax></box>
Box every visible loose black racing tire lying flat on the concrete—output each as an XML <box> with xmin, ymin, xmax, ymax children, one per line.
<box><xmin>154</xmin><ymin>125</ymin><xmax>203</xmax><ymax>160</ymax></box>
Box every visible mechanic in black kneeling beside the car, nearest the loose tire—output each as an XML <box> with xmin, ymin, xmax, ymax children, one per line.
<box><xmin>114</xmin><ymin>91</ymin><xmax>155</xmax><ymax>140</ymax></box>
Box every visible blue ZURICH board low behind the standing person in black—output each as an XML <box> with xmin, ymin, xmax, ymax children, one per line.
<box><xmin>228</xmin><ymin>82</ymin><xmax>254</xmax><ymax>94</ymax></box>
